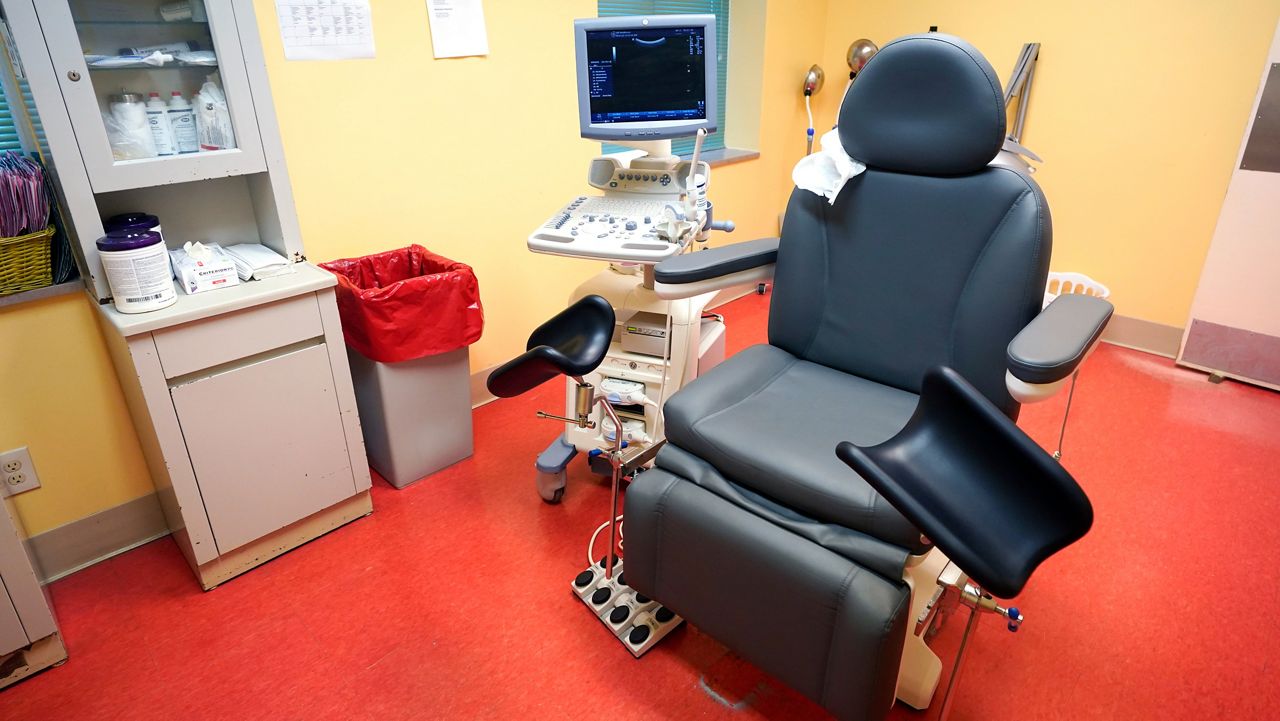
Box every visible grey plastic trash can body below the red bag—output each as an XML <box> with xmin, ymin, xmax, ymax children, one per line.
<box><xmin>347</xmin><ymin>347</ymin><xmax>474</xmax><ymax>488</ymax></box>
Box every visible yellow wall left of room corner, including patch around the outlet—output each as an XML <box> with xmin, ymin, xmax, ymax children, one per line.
<box><xmin>0</xmin><ymin>0</ymin><xmax>826</xmax><ymax>534</ymax></box>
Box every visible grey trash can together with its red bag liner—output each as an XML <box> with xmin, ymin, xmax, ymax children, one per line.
<box><xmin>320</xmin><ymin>245</ymin><xmax>484</xmax><ymax>488</ymax></box>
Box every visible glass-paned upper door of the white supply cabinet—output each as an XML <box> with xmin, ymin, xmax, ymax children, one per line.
<box><xmin>36</xmin><ymin>0</ymin><xmax>266</xmax><ymax>192</ymax></box>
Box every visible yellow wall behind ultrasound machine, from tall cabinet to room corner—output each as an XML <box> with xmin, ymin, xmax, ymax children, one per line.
<box><xmin>244</xmin><ymin>0</ymin><xmax>826</xmax><ymax>370</ymax></box>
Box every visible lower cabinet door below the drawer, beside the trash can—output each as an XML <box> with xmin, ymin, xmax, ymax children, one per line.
<box><xmin>170</xmin><ymin>343</ymin><xmax>356</xmax><ymax>553</ymax></box>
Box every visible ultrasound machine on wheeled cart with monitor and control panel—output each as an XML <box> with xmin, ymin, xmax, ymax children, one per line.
<box><xmin>529</xmin><ymin>15</ymin><xmax>733</xmax><ymax>503</ymax></box>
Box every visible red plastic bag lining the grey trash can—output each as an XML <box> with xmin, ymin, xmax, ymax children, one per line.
<box><xmin>320</xmin><ymin>245</ymin><xmax>484</xmax><ymax>362</ymax></box>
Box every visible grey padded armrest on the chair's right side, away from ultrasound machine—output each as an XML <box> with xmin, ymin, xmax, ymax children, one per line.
<box><xmin>1009</xmin><ymin>293</ymin><xmax>1115</xmax><ymax>383</ymax></box>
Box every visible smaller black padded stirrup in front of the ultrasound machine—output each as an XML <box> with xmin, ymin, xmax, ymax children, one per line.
<box><xmin>486</xmin><ymin>296</ymin><xmax>614</xmax><ymax>398</ymax></box>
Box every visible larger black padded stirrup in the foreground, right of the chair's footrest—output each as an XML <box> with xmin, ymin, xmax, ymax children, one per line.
<box><xmin>836</xmin><ymin>366</ymin><xmax>1093</xmax><ymax>598</ymax></box>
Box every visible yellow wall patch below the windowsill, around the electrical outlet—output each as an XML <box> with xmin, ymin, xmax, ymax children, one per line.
<box><xmin>0</xmin><ymin>293</ymin><xmax>154</xmax><ymax>535</ymax></box>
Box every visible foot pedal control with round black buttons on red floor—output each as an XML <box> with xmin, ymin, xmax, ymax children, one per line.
<box><xmin>570</xmin><ymin>558</ymin><xmax>684</xmax><ymax>658</ymax></box>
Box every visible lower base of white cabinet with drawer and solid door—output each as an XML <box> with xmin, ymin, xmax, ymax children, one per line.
<box><xmin>102</xmin><ymin>274</ymin><xmax>372</xmax><ymax>589</ymax></box>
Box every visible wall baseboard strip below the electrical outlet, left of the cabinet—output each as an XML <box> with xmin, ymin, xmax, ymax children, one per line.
<box><xmin>27</xmin><ymin>493</ymin><xmax>169</xmax><ymax>583</ymax></box>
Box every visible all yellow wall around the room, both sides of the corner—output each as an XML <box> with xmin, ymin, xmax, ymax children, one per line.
<box><xmin>12</xmin><ymin>0</ymin><xmax>1259</xmax><ymax>542</ymax></box>
